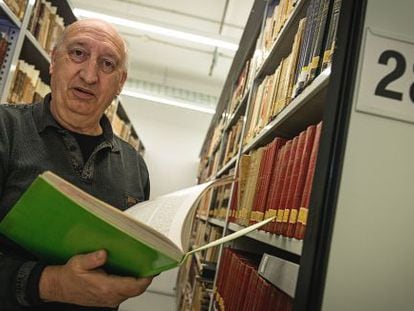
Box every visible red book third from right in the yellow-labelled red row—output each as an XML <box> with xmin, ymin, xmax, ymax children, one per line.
<box><xmin>280</xmin><ymin>131</ymin><xmax>306</xmax><ymax>235</ymax></box>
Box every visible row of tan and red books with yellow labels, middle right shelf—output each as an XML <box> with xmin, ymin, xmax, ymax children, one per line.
<box><xmin>229</xmin><ymin>123</ymin><xmax>322</xmax><ymax>239</ymax></box>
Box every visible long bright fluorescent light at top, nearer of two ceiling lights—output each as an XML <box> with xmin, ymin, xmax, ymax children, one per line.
<box><xmin>74</xmin><ymin>9</ymin><xmax>239</xmax><ymax>51</ymax></box>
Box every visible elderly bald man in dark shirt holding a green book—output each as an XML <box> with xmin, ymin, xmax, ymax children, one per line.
<box><xmin>0</xmin><ymin>20</ymin><xmax>151</xmax><ymax>311</ymax></box>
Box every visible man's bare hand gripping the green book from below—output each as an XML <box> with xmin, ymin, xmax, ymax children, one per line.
<box><xmin>39</xmin><ymin>250</ymin><xmax>152</xmax><ymax>307</ymax></box>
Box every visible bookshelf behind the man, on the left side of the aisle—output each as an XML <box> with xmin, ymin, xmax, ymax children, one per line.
<box><xmin>0</xmin><ymin>0</ymin><xmax>145</xmax><ymax>155</ymax></box>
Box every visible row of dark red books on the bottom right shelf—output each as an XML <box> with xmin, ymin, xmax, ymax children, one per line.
<box><xmin>215</xmin><ymin>248</ymin><xmax>293</xmax><ymax>311</ymax></box>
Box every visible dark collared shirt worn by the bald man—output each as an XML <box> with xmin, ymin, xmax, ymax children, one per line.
<box><xmin>0</xmin><ymin>95</ymin><xmax>150</xmax><ymax>310</ymax></box>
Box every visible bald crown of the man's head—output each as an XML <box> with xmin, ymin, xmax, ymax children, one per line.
<box><xmin>55</xmin><ymin>18</ymin><xmax>128</xmax><ymax>72</ymax></box>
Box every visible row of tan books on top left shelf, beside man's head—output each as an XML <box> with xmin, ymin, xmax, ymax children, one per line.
<box><xmin>27</xmin><ymin>0</ymin><xmax>65</xmax><ymax>53</ymax></box>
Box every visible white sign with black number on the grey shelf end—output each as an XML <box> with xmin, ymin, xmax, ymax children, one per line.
<box><xmin>356</xmin><ymin>28</ymin><xmax>414</xmax><ymax>123</ymax></box>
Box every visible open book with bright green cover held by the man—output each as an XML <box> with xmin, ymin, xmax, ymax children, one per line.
<box><xmin>0</xmin><ymin>171</ymin><xmax>272</xmax><ymax>277</ymax></box>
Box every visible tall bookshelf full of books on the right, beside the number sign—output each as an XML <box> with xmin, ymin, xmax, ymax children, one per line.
<box><xmin>179</xmin><ymin>0</ymin><xmax>376</xmax><ymax>310</ymax></box>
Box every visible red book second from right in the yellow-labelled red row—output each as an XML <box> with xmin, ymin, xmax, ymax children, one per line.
<box><xmin>286</xmin><ymin>125</ymin><xmax>316</xmax><ymax>238</ymax></box>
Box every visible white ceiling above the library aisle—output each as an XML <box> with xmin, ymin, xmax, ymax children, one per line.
<box><xmin>70</xmin><ymin>0</ymin><xmax>254</xmax><ymax>111</ymax></box>
